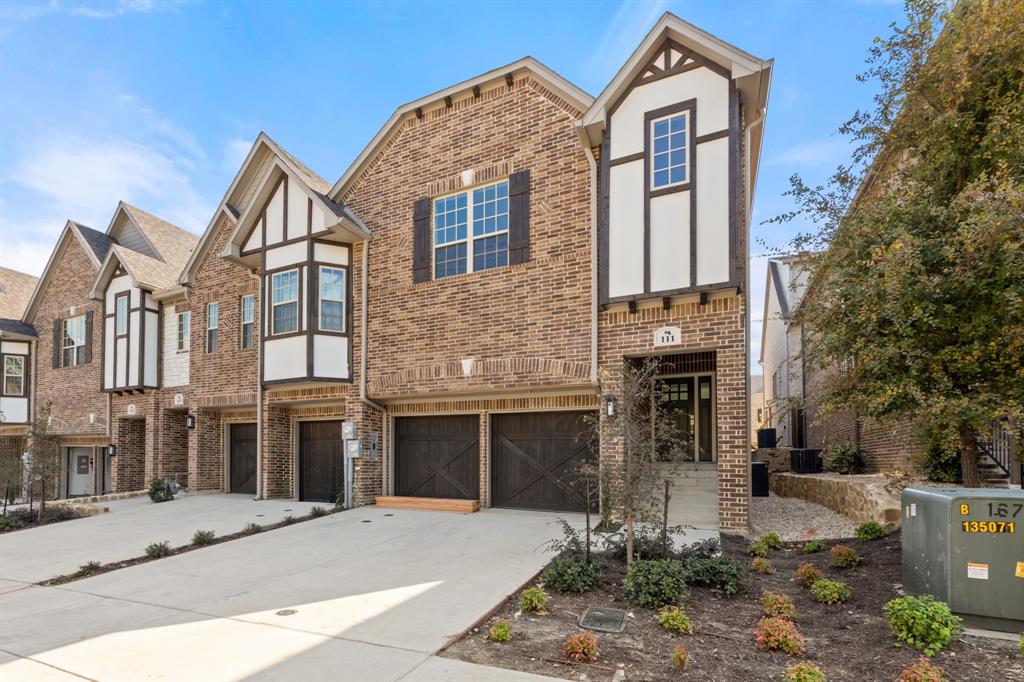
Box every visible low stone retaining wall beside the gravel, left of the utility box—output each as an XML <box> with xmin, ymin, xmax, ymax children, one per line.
<box><xmin>768</xmin><ymin>473</ymin><xmax>900</xmax><ymax>527</ymax></box>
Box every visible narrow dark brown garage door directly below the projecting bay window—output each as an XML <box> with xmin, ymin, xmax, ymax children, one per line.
<box><xmin>299</xmin><ymin>421</ymin><xmax>345</xmax><ymax>502</ymax></box>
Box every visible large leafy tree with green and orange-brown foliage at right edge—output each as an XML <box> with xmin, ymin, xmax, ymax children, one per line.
<box><xmin>769</xmin><ymin>0</ymin><xmax>1024</xmax><ymax>486</ymax></box>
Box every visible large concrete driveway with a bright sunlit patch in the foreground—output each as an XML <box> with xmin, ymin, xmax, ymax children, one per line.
<box><xmin>0</xmin><ymin>502</ymin><xmax>559</xmax><ymax>681</ymax></box>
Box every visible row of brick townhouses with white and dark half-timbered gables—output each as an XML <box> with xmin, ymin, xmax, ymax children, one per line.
<box><xmin>0</xmin><ymin>14</ymin><xmax>772</xmax><ymax>529</ymax></box>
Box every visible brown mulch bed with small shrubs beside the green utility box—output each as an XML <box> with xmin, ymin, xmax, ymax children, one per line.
<box><xmin>442</xmin><ymin>532</ymin><xmax>1024</xmax><ymax>682</ymax></box>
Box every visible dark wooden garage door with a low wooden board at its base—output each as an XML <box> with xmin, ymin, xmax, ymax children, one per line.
<box><xmin>394</xmin><ymin>415</ymin><xmax>480</xmax><ymax>500</ymax></box>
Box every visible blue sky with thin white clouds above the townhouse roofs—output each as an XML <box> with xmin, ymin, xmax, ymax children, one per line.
<box><xmin>0</xmin><ymin>0</ymin><xmax>901</xmax><ymax>371</ymax></box>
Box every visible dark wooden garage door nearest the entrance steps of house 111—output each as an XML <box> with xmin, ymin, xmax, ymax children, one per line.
<box><xmin>490</xmin><ymin>412</ymin><xmax>597</xmax><ymax>511</ymax></box>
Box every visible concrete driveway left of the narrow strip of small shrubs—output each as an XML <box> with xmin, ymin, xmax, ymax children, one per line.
<box><xmin>0</xmin><ymin>495</ymin><xmax>324</xmax><ymax>583</ymax></box>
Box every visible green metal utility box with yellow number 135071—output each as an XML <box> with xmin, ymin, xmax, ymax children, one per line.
<box><xmin>901</xmin><ymin>487</ymin><xmax>1024</xmax><ymax>632</ymax></box>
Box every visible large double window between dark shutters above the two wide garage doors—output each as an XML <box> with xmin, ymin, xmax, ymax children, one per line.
<box><xmin>434</xmin><ymin>180</ymin><xmax>509</xmax><ymax>280</ymax></box>
